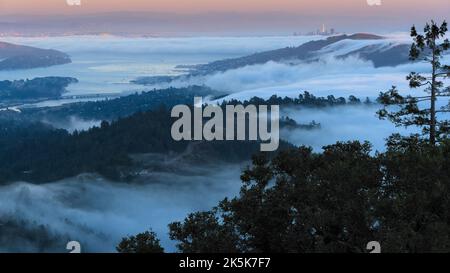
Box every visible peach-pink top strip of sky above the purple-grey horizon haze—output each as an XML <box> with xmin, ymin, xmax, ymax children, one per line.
<box><xmin>0</xmin><ymin>0</ymin><xmax>450</xmax><ymax>16</ymax></box>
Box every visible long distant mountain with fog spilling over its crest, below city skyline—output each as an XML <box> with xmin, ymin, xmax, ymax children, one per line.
<box><xmin>133</xmin><ymin>33</ymin><xmax>410</xmax><ymax>85</ymax></box>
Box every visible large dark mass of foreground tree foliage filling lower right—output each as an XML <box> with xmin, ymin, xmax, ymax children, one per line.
<box><xmin>165</xmin><ymin>140</ymin><xmax>450</xmax><ymax>253</ymax></box>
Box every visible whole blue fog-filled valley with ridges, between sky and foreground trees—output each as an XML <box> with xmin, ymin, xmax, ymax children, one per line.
<box><xmin>0</xmin><ymin>33</ymin><xmax>450</xmax><ymax>252</ymax></box>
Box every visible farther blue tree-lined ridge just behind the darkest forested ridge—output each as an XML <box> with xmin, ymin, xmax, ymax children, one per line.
<box><xmin>14</xmin><ymin>85</ymin><xmax>372</xmax><ymax>121</ymax></box>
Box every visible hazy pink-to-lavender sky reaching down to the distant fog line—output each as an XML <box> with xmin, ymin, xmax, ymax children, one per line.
<box><xmin>0</xmin><ymin>0</ymin><xmax>450</xmax><ymax>34</ymax></box>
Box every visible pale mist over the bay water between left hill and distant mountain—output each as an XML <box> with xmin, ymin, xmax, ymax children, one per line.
<box><xmin>0</xmin><ymin>36</ymin><xmax>322</xmax><ymax>95</ymax></box>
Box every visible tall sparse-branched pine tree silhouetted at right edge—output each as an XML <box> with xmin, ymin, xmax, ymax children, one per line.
<box><xmin>378</xmin><ymin>21</ymin><xmax>450</xmax><ymax>145</ymax></box>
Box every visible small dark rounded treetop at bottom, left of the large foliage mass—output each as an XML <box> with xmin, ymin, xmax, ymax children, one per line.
<box><xmin>116</xmin><ymin>231</ymin><xmax>164</xmax><ymax>253</ymax></box>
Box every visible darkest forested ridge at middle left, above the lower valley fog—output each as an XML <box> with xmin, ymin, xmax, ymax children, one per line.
<box><xmin>0</xmin><ymin>105</ymin><xmax>289</xmax><ymax>183</ymax></box>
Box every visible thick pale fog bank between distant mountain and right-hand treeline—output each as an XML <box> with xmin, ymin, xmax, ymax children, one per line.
<box><xmin>207</xmin><ymin>55</ymin><xmax>450</xmax><ymax>100</ymax></box>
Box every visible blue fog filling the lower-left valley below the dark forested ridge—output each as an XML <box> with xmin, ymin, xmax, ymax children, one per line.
<box><xmin>0</xmin><ymin>165</ymin><xmax>243</xmax><ymax>252</ymax></box>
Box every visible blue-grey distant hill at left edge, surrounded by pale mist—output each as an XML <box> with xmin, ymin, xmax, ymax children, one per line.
<box><xmin>0</xmin><ymin>42</ymin><xmax>72</xmax><ymax>70</ymax></box>
